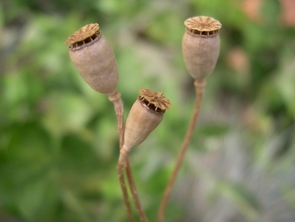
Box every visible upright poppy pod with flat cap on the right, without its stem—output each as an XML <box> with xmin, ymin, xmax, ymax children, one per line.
<box><xmin>182</xmin><ymin>16</ymin><xmax>221</xmax><ymax>81</ymax></box>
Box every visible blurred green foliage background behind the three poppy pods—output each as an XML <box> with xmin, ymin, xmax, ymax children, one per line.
<box><xmin>0</xmin><ymin>0</ymin><xmax>295</xmax><ymax>222</ymax></box>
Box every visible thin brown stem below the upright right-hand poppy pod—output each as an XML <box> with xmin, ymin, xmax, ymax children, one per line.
<box><xmin>158</xmin><ymin>80</ymin><xmax>206</xmax><ymax>222</ymax></box>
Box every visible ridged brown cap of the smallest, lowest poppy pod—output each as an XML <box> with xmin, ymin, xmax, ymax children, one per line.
<box><xmin>139</xmin><ymin>89</ymin><xmax>171</xmax><ymax>113</ymax></box>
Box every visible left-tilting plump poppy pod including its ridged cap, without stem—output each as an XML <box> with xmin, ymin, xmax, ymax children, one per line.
<box><xmin>65</xmin><ymin>23</ymin><xmax>119</xmax><ymax>94</ymax></box>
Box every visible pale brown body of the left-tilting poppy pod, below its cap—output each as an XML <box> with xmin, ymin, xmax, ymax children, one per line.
<box><xmin>69</xmin><ymin>35</ymin><xmax>119</xmax><ymax>94</ymax></box>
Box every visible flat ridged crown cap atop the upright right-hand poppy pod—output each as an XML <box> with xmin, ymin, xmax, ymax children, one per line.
<box><xmin>184</xmin><ymin>16</ymin><xmax>222</xmax><ymax>35</ymax></box>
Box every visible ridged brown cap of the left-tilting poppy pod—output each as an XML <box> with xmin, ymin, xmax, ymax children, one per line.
<box><xmin>65</xmin><ymin>23</ymin><xmax>101</xmax><ymax>49</ymax></box>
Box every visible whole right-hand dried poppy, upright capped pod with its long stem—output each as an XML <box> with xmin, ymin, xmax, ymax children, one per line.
<box><xmin>158</xmin><ymin>16</ymin><xmax>221</xmax><ymax>222</ymax></box>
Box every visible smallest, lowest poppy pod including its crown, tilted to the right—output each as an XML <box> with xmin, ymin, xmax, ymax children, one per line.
<box><xmin>123</xmin><ymin>89</ymin><xmax>171</xmax><ymax>152</ymax></box>
